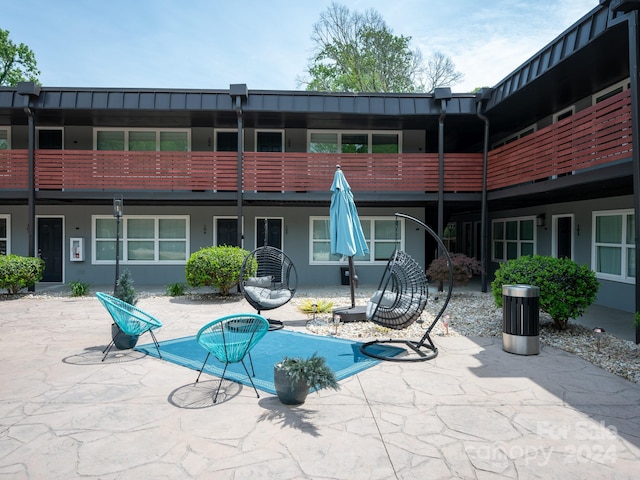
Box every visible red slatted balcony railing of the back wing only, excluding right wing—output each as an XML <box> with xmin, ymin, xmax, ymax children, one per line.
<box><xmin>0</xmin><ymin>150</ymin><xmax>482</xmax><ymax>192</ymax></box>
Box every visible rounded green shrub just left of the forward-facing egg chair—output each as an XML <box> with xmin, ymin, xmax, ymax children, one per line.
<box><xmin>185</xmin><ymin>245</ymin><xmax>249</xmax><ymax>295</ymax></box>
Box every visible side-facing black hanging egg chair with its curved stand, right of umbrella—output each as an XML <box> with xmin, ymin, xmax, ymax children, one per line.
<box><xmin>360</xmin><ymin>213</ymin><xmax>453</xmax><ymax>362</ymax></box>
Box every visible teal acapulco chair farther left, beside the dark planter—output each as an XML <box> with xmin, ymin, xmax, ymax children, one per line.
<box><xmin>96</xmin><ymin>292</ymin><xmax>162</xmax><ymax>362</ymax></box>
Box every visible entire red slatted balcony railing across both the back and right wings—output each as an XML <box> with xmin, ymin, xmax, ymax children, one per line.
<box><xmin>0</xmin><ymin>92</ymin><xmax>632</xmax><ymax>193</ymax></box>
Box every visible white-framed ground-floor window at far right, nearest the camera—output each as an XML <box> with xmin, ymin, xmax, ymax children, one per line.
<box><xmin>591</xmin><ymin>210</ymin><xmax>636</xmax><ymax>283</ymax></box>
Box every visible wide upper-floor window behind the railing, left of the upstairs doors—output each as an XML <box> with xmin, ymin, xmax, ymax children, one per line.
<box><xmin>93</xmin><ymin>128</ymin><xmax>191</xmax><ymax>152</ymax></box>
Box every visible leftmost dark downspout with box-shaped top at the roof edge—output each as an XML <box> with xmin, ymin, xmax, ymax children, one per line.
<box><xmin>17</xmin><ymin>82</ymin><xmax>40</xmax><ymax>292</ymax></box>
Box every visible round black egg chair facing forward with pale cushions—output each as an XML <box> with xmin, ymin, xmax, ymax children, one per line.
<box><xmin>239</xmin><ymin>245</ymin><xmax>298</xmax><ymax>330</ymax></box>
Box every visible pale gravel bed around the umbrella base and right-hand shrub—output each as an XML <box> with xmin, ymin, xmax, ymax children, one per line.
<box><xmin>292</xmin><ymin>286</ymin><xmax>640</xmax><ymax>383</ymax></box>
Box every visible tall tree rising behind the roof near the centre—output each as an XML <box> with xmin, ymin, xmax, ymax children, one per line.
<box><xmin>298</xmin><ymin>3</ymin><xmax>462</xmax><ymax>92</ymax></box>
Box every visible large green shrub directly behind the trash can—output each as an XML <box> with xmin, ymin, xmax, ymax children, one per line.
<box><xmin>491</xmin><ymin>255</ymin><xmax>600</xmax><ymax>330</ymax></box>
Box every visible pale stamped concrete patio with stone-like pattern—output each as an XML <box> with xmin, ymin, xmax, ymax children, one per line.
<box><xmin>0</xmin><ymin>286</ymin><xmax>640</xmax><ymax>480</ymax></box>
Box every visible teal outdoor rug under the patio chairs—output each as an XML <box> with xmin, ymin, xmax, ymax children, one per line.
<box><xmin>135</xmin><ymin>330</ymin><xmax>404</xmax><ymax>394</ymax></box>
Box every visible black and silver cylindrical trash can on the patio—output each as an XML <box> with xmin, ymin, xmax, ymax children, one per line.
<box><xmin>502</xmin><ymin>285</ymin><xmax>540</xmax><ymax>355</ymax></box>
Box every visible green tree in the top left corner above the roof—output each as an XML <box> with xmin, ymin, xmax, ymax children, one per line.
<box><xmin>0</xmin><ymin>28</ymin><xmax>40</xmax><ymax>87</ymax></box>
